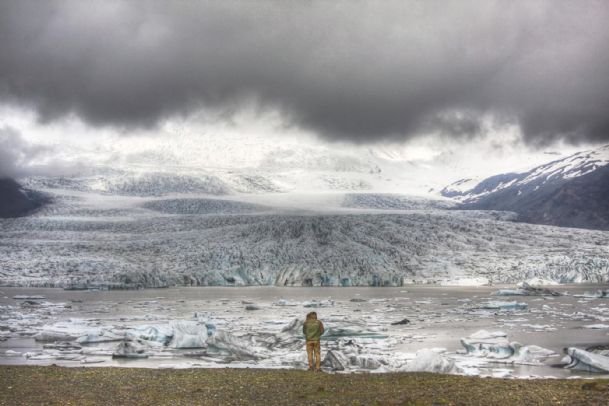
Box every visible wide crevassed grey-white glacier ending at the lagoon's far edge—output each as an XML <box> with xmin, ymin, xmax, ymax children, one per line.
<box><xmin>0</xmin><ymin>189</ymin><xmax>609</xmax><ymax>289</ymax></box>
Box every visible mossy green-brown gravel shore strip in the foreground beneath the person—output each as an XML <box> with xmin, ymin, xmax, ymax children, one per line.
<box><xmin>0</xmin><ymin>366</ymin><xmax>609</xmax><ymax>406</ymax></box>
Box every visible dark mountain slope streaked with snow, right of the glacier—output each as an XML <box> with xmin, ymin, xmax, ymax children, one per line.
<box><xmin>441</xmin><ymin>145</ymin><xmax>609</xmax><ymax>229</ymax></box>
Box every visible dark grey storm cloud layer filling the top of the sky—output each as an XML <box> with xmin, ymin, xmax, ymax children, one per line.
<box><xmin>0</xmin><ymin>0</ymin><xmax>609</xmax><ymax>144</ymax></box>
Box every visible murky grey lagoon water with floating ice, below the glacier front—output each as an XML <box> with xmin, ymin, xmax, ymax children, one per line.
<box><xmin>0</xmin><ymin>285</ymin><xmax>609</xmax><ymax>377</ymax></box>
